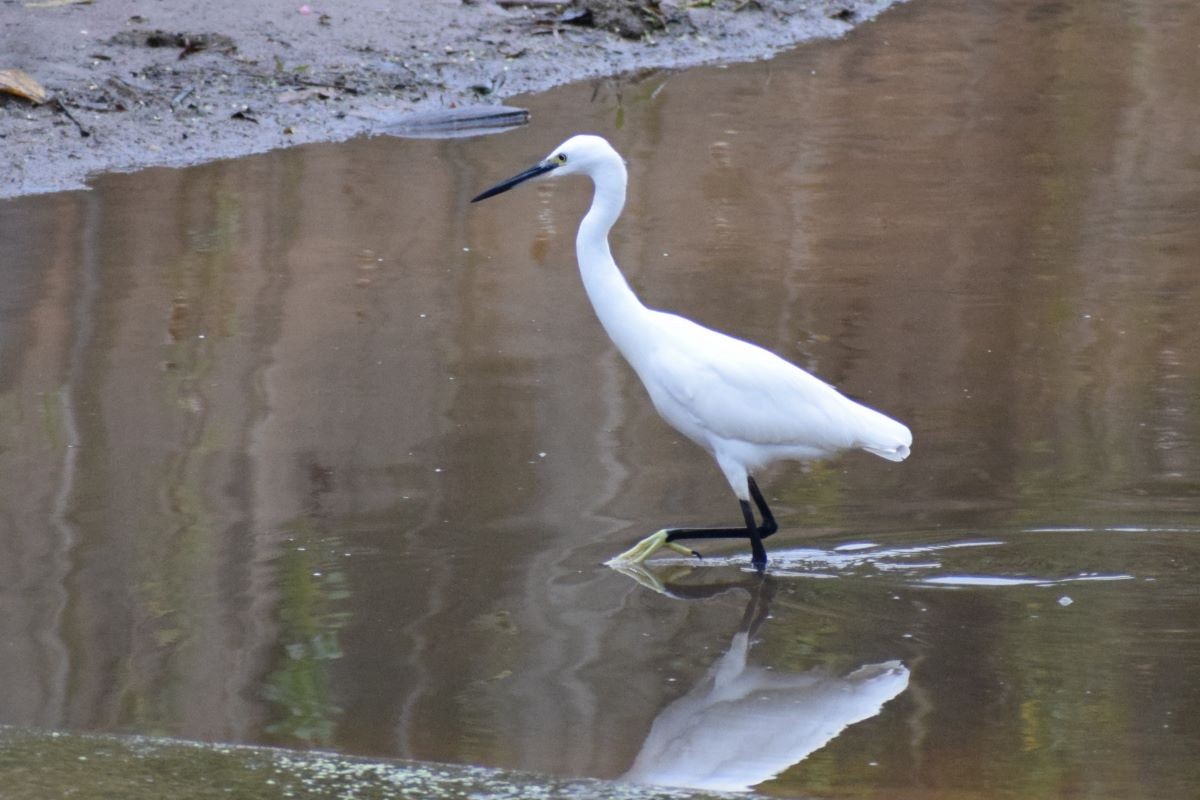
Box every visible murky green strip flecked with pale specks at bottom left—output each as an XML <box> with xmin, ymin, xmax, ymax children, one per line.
<box><xmin>0</xmin><ymin>728</ymin><xmax>746</xmax><ymax>800</ymax></box>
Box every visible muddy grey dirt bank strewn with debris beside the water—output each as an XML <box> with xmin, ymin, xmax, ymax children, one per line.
<box><xmin>0</xmin><ymin>0</ymin><xmax>895</xmax><ymax>198</ymax></box>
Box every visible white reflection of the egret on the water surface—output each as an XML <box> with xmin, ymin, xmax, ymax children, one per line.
<box><xmin>622</xmin><ymin>569</ymin><xmax>908</xmax><ymax>792</ymax></box>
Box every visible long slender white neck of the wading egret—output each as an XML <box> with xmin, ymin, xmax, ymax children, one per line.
<box><xmin>575</xmin><ymin>158</ymin><xmax>646</xmax><ymax>366</ymax></box>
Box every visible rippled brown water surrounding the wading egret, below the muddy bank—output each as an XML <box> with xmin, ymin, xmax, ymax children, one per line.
<box><xmin>0</xmin><ymin>0</ymin><xmax>1200</xmax><ymax>800</ymax></box>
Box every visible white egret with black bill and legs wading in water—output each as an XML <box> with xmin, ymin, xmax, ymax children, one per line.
<box><xmin>472</xmin><ymin>134</ymin><xmax>912</xmax><ymax>571</ymax></box>
